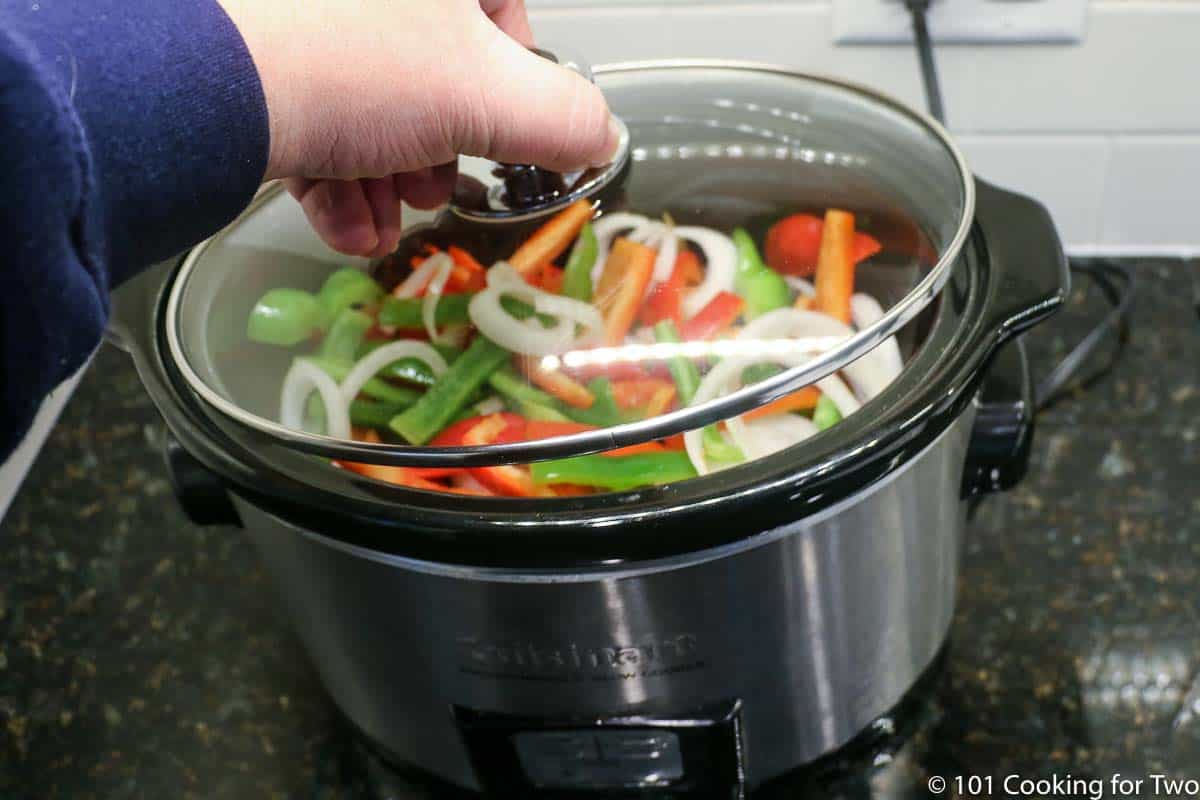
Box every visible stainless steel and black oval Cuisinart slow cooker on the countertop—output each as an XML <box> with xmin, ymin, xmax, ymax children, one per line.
<box><xmin>113</xmin><ymin>61</ymin><xmax>1068</xmax><ymax>798</ymax></box>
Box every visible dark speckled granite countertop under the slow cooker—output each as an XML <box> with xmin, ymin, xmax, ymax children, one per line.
<box><xmin>0</xmin><ymin>261</ymin><xmax>1200</xmax><ymax>800</ymax></box>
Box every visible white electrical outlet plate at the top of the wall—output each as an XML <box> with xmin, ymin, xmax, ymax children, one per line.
<box><xmin>833</xmin><ymin>0</ymin><xmax>1087</xmax><ymax>44</ymax></box>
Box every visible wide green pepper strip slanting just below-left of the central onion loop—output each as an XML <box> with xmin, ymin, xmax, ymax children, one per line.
<box><xmin>390</xmin><ymin>336</ymin><xmax>511</xmax><ymax>445</ymax></box>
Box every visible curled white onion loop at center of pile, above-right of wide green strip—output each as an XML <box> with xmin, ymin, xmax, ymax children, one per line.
<box><xmin>467</xmin><ymin>261</ymin><xmax>604</xmax><ymax>355</ymax></box>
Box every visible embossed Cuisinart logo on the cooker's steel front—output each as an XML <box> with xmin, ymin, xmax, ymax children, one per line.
<box><xmin>458</xmin><ymin>633</ymin><xmax>704</xmax><ymax>682</ymax></box>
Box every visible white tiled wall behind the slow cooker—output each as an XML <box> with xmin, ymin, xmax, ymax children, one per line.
<box><xmin>527</xmin><ymin>0</ymin><xmax>1200</xmax><ymax>254</ymax></box>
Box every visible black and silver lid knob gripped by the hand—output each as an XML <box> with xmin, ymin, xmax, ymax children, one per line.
<box><xmin>450</xmin><ymin>48</ymin><xmax>629</xmax><ymax>222</ymax></box>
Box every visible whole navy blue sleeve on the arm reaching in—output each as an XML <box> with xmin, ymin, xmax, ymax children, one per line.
<box><xmin>0</xmin><ymin>0</ymin><xmax>270</xmax><ymax>462</ymax></box>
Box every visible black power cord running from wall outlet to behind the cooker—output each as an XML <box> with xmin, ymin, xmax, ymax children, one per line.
<box><xmin>904</xmin><ymin>0</ymin><xmax>1137</xmax><ymax>410</ymax></box>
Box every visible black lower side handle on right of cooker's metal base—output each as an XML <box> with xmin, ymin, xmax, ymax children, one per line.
<box><xmin>962</xmin><ymin>339</ymin><xmax>1034</xmax><ymax>499</ymax></box>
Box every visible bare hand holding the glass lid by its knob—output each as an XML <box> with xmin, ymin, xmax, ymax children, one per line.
<box><xmin>214</xmin><ymin>0</ymin><xmax>618</xmax><ymax>257</ymax></box>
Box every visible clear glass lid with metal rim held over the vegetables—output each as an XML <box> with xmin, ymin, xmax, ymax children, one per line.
<box><xmin>163</xmin><ymin>62</ymin><xmax>974</xmax><ymax>495</ymax></box>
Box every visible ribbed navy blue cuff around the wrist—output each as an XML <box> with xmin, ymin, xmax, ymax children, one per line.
<box><xmin>4</xmin><ymin>0</ymin><xmax>270</xmax><ymax>285</ymax></box>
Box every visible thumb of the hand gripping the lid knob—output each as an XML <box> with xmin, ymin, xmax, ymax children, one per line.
<box><xmin>458</xmin><ymin>30</ymin><xmax>620</xmax><ymax>172</ymax></box>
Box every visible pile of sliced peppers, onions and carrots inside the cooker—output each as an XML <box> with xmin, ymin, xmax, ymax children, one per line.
<box><xmin>247</xmin><ymin>200</ymin><xmax>901</xmax><ymax>497</ymax></box>
